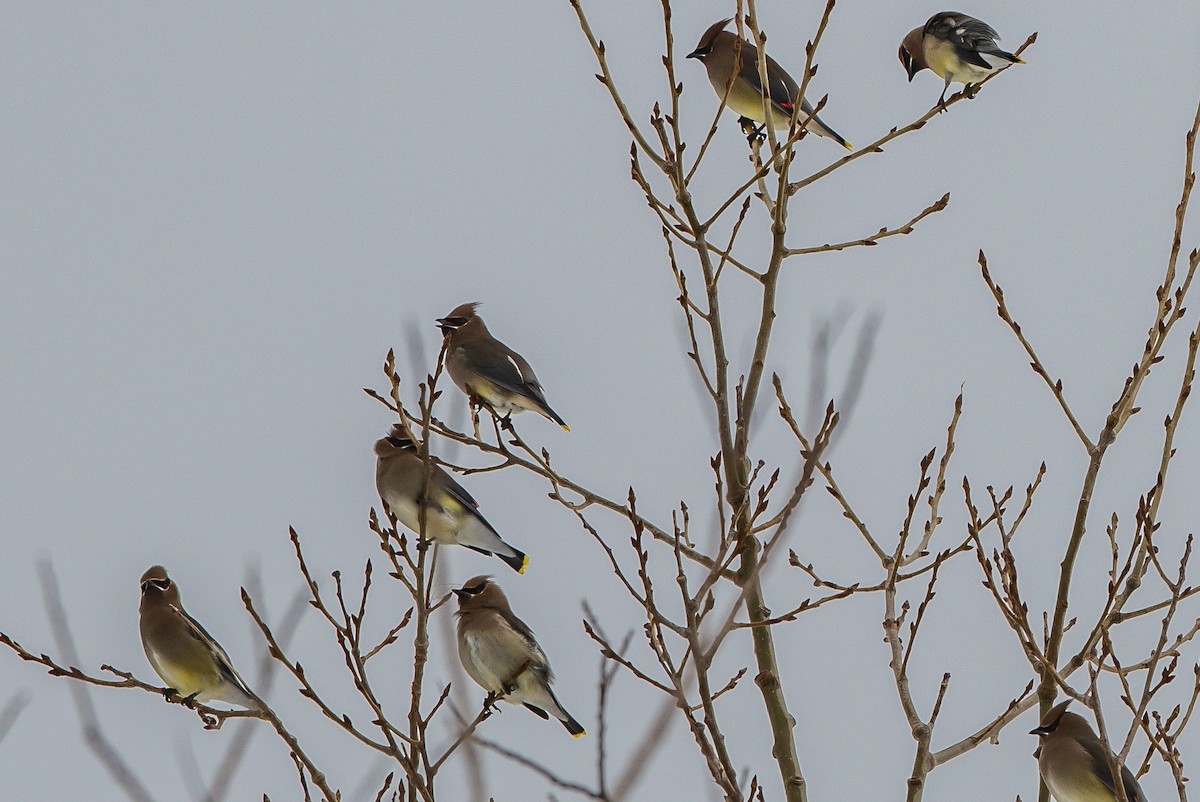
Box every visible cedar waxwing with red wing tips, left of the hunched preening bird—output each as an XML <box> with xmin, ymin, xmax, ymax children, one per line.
<box><xmin>688</xmin><ymin>17</ymin><xmax>854</xmax><ymax>150</ymax></box>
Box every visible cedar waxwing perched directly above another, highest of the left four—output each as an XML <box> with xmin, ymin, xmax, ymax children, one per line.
<box><xmin>437</xmin><ymin>303</ymin><xmax>571</xmax><ymax>431</ymax></box>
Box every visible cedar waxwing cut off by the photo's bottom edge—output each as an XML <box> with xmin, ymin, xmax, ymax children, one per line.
<box><xmin>1030</xmin><ymin>699</ymin><xmax>1146</xmax><ymax>802</ymax></box>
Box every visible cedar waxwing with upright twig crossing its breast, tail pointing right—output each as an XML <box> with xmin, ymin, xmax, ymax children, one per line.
<box><xmin>374</xmin><ymin>424</ymin><xmax>529</xmax><ymax>574</ymax></box>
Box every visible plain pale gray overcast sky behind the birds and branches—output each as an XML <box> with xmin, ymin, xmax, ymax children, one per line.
<box><xmin>0</xmin><ymin>0</ymin><xmax>1200</xmax><ymax>802</ymax></box>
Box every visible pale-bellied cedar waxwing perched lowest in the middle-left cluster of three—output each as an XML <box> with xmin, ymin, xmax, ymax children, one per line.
<box><xmin>455</xmin><ymin>576</ymin><xmax>587</xmax><ymax>738</ymax></box>
